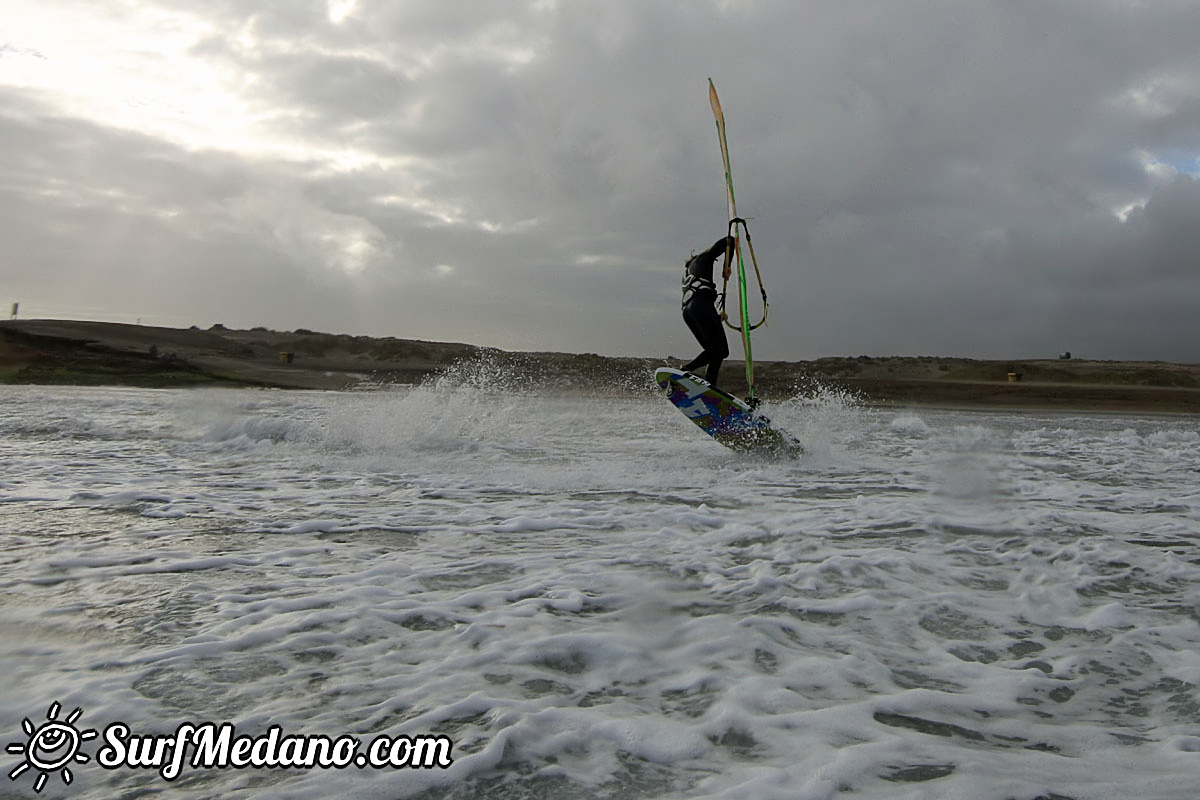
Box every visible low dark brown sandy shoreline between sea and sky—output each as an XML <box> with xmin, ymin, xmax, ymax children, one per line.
<box><xmin>0</xmin><ymin>319</ymin><xmax>1200</xmax><ymax>414</ymax></box>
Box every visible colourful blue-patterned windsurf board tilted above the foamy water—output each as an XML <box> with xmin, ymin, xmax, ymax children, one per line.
<box><xmin>654</xmin><ymin>367</ymin><xmax>804</xmax><ymax>455</ymax></box>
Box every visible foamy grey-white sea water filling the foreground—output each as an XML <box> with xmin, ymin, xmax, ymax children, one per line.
<box><xmin>0</xmin><ymin>369</ymin><xmax>1200</xmax><ymax>800</ymax></box>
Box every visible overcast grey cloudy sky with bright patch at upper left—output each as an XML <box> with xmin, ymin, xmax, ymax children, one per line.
<box><xmin>0</xmin><ymin>0</ymin><xmax>1200</xmax><ymax>362</ymax></box>
